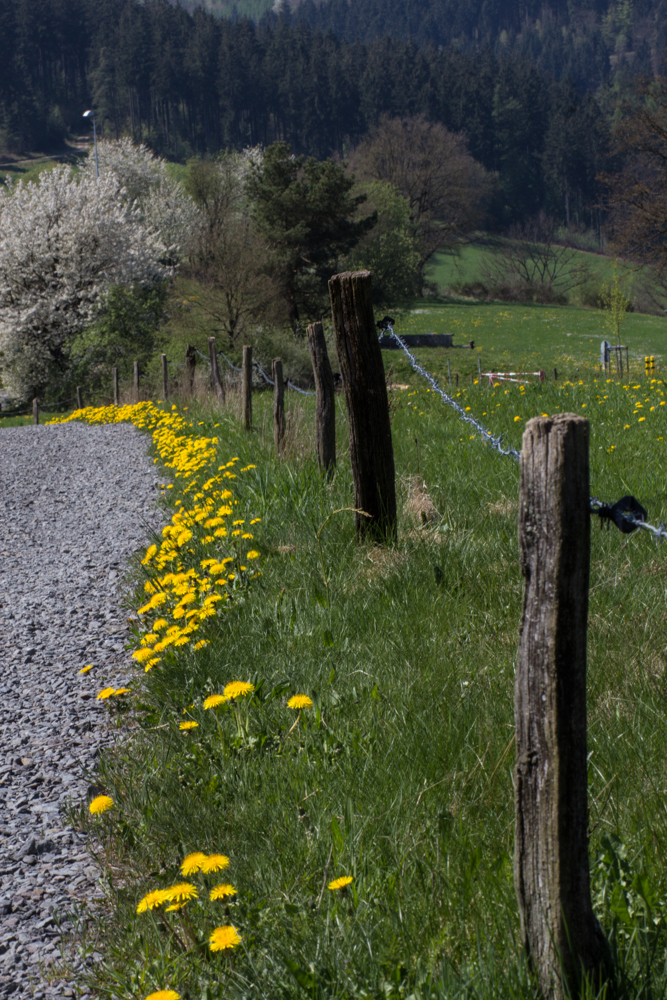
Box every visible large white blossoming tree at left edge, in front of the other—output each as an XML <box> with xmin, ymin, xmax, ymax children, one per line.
<box><xmin>0</xmin><ymin>167</ymin><xmax>171</xmax><ymax>400</ymax></box>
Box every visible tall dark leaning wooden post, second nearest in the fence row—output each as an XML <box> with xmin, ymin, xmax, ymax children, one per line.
<box><xmin>329</xmin><ymin>271</ymin><xmax>396</xmax><ymax>541</ymax></box>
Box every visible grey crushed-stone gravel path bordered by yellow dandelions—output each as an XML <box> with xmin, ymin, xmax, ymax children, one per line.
<box><xmin>0</xmin><ymin>423</ymin><xmax>162</xmax><ymax>1000</ymax></box>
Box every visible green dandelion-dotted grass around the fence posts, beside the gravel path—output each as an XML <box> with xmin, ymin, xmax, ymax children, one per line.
<box><xmin>49</xmin><ymin>364</ymin><xmax>667</xmax><ymax>998</ymax></box>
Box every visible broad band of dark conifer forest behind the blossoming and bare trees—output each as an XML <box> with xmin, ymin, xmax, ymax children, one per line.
<box><xmin>0</xmin><ymin>0</ymin><xmax>605</xmax><ymax>225</ymax></box>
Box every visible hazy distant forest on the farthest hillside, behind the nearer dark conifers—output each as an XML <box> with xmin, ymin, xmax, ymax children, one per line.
<box><xmin>284</xmin><ymin>0</ymin><xmax>667</xmax><ymax>93</ymax></box>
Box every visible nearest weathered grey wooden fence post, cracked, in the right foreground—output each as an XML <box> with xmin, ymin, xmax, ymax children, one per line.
<box><xmin>514</xmin><ymin>413</ymin><xmax>607</xmax><ymax>1000</ymax></box>
